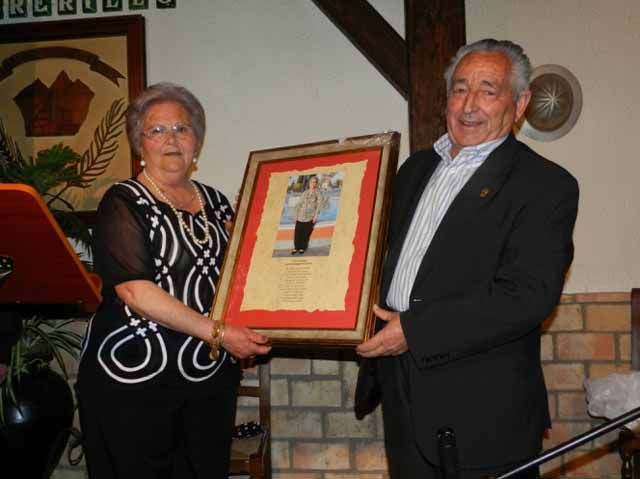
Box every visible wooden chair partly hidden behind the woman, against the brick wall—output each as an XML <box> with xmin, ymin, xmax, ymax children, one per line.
<box><xmin>229</xmin><ymin>363</ymin><xmax>271</xmax><ymax>479</ymax></box>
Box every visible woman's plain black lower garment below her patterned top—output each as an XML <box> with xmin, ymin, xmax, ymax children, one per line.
<box><xmin>78</xmin><ymin>376</ymin><xmax>237</xmax><ymax>479</ymax></box>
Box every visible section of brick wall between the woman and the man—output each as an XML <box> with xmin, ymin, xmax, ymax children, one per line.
<box><xmin>238</xmin><ymin>358</ymin><xmax>386</xmax><ymax>479</ymax></box>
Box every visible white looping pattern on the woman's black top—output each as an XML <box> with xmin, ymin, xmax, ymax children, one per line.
<box><xmin>92</xmin><ymin>180</ymin><xmax>235</xmax><ymax>384</ymax></box>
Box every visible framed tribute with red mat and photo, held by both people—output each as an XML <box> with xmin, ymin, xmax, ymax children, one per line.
<box><xmin>211</xmin><ymin>132</ymin><xmax>400</xmax><ymax>347</ymax></box>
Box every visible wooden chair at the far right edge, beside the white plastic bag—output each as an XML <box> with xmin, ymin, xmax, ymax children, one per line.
<box><xmin>618</xmin><ymin>288</ymin><xmax>640</xmax><ymax>479</ymax></box>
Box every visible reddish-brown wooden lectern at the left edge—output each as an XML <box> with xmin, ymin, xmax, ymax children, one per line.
<box><xmin>0</xmin><ymin>184</ymin><xmax>101</xmax><ymax>311</ymax></box>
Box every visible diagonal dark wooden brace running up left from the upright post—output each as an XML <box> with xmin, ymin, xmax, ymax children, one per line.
<box><xmin>313</xmin><ymin>0</ymin><xmax>410</xmax><ymax>99</ymax></box>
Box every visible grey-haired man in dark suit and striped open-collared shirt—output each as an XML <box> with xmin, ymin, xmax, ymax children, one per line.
<box><xmin>356</xmin><ymin>39</ymin><xmax>578</xmax><ymax>479</ymax></box>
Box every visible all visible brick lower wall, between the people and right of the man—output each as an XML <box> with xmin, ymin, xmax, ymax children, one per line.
<box><xmin>54</xmin><ymin>293</ymin><xmax>631</xmax><ymax>479</ymax></box>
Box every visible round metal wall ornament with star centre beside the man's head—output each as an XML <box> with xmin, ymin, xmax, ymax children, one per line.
<box><xmin>520</xmin><ymin>65</ymin><xmax>582</xmax><ymax>141</ymax></box>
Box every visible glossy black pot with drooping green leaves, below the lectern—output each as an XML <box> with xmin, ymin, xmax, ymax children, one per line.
<box><xmin>0</xmin><ymin>314</ymin><xmax>82</xmax><ymax>478</ymax></box>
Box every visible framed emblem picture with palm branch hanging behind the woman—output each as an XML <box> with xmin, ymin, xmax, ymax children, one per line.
<box><xmin>0</xmin><ymin>15</ymin><xmax>146</xmax><ymax>218</ymax></box>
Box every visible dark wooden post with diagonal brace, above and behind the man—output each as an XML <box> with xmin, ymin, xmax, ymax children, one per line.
<box><xmin>313</xmin><ymin>0</ymin><xmax>466</xmax><ymax>152</ymax></box>
